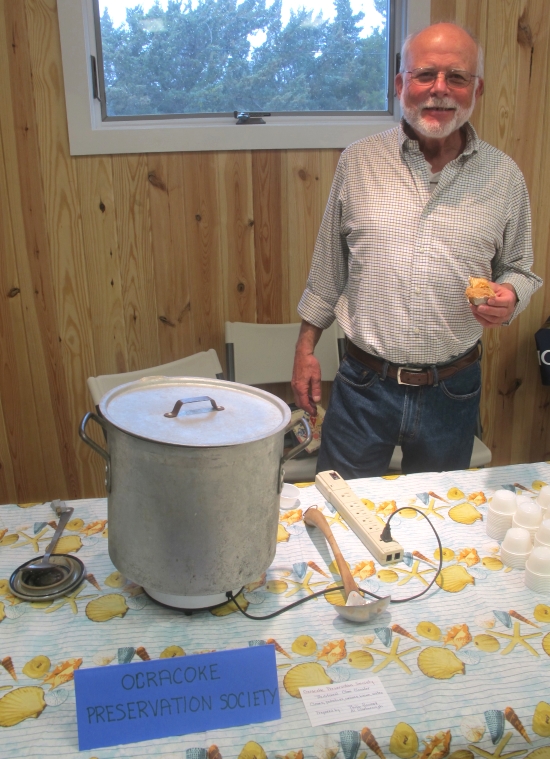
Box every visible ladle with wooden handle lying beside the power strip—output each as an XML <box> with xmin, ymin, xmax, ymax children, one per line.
<box><xmin>304</xmin><ymin>506</ymin><xmax>390</xmax><ymax>622</ymax></box>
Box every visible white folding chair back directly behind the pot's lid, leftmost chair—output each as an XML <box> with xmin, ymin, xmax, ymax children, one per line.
<box><xmin>88</xmin><ymin>348</ymin><xmax>223</xmax><ymax>407</ymax></box>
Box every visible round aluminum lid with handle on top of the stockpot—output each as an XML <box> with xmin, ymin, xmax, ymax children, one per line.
<box><xmin>99</xmin><ymin>377</ymin><xmax>290</xmax><ymax>447</ymax></box>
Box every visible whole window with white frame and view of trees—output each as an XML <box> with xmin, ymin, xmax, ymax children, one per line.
<box><xmin>58</xmin><ymin>0</ymin><xmax>429</xmax><ymax>155</ymax></box>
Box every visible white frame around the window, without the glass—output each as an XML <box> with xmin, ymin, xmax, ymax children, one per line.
<box><xmin>57</xmin><ymin>0</ymin><xmax>436</xmax><ymax>155</ymax></box>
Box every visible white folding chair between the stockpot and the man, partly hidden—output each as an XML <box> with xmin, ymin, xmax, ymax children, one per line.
<box><xmin>225</xmin><ymin>322</ymin><xmax>343</xmax><ymax>482</ymax></box>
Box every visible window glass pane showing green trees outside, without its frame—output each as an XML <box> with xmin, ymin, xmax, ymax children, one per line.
<box><xmin>97</xmin><ymin>0</ymin><xmax>395</xmax><ymax>120</ymax></box>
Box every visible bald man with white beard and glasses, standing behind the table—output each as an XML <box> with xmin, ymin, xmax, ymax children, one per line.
<box><xmin>292</xmin><ymin>23</ymin><xmax>542</xmax><ymax>478</ymax></box>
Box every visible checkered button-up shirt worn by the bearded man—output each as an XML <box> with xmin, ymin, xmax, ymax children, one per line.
<box><xmin>298</xmin><ymin>124</ymin><xmax>542</xmax><ymax>364</ymax></box>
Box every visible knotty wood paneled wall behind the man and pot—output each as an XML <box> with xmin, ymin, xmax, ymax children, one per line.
<box><xmin>0</xmin><ymin>0</ymin><xmax>550</xmax><ymax>503</ymax></box>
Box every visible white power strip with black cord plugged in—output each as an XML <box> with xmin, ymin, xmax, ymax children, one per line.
<box><xmin>315</xmin><ymin>470</ymin><xmax>403</xmax><ymax>565</ymax></box>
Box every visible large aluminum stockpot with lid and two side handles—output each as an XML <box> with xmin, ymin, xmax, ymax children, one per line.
<box><xmin>80</xmin><ymin>377</ymin><xmax>307</xmax><ymax>608</ymax></box>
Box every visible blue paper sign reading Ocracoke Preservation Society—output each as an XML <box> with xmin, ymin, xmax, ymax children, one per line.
<box><xmin>74</xmin><ymin>645</ymin><xmax>281</xmax><ymax>751</ymax></box>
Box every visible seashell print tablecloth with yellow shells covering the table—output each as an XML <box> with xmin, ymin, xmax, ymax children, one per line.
<box><xmin>0</xmin><ymin>463</ymin><xmax>550</xmax><ymax>759</ymax></box>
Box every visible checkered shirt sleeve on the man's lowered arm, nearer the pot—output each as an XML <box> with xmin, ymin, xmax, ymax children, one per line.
<box><xmin>298</xmin><ymin>151</ymin><xmax>349</xmax><ymax>329</ymax></box>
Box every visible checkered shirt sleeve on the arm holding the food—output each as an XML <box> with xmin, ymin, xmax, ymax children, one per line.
<box><xmin>492</xmin><ymin>168</ymin><xmax>542</xmax><ymax>324</ymax></box>
